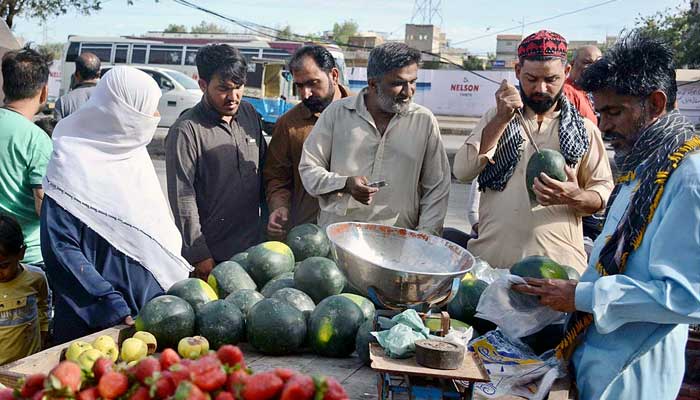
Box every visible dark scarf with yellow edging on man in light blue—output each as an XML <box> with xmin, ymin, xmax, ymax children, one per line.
<box><xmin>556</xmin><ymin>110</ymin><xmax>700</xmax><ymax>359</ymax></box>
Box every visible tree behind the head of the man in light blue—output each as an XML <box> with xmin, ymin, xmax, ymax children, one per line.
<box><xmin>637</xmin><ymin>7</ymin><xmax>700</xmax><ymax>68</ymax></box>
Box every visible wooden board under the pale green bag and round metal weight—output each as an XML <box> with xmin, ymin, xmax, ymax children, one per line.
<box><xmin>369</xmin><ymin>343</ymin><xmax>489</xmax><ymax>382</ymax></box>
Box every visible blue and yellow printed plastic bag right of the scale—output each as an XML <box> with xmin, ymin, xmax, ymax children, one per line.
<box><xmin>458</xmin><ymin>330</ymin><xmax>566</xmax><ymax>400</ymax></box>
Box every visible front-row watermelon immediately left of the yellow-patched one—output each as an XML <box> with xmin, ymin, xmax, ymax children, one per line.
<box><xmin>246</xmin><ymin>299</ymin><xmax>306</xmax><ymax>355</ymax></box>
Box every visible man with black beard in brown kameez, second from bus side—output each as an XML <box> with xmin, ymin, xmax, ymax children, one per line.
<box><xmin>263</xmin><ymin>45</ymin><xmax>350</xmax><ymax>240</ymax></box>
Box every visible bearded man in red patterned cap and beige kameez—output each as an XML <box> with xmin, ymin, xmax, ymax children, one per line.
<box><xmin>454</xmin><ymin>31</ymin><xmax>613</xmax><ymax>272</ymax></box>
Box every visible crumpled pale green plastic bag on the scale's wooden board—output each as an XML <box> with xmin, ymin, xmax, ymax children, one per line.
<box><xmin>372</xmin><ymin>309</ymin><xmax>431</xmax><ymax>358</ymax></box>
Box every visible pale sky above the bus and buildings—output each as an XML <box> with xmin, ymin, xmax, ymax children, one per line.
<box><xmin>13</xmin><ymin>0</ymin><xmax>689</xmax><ymax>55</ymax></box>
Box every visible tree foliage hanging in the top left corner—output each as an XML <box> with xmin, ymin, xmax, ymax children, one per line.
<box><xmin>0</xmin><ymin>0</ymin><xmax>104</xmax><ymax>28</ymax></box>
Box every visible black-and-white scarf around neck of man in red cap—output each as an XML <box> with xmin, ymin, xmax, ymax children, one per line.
<box><xmin>478</xmin><ymin>95</ymin><xmax>590</xmax><ymax>192</ymax></box>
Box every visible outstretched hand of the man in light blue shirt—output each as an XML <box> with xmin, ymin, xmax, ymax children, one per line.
<box><xmin>510</xmin><ymin>278</ymin><xmax>578</xmax><ymax>313</ymax></box>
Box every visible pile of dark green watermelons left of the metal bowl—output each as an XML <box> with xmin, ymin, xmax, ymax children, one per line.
<box><xmin>136</xmin><ymin>224</ymin><xmax>375</xmax><ymax>357</ymax></box>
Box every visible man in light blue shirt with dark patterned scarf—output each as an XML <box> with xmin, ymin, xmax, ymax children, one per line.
<box><xmin>513</xmin><ymin>32</ymin><xmax>700</xmax><ymax>400</ymax></box>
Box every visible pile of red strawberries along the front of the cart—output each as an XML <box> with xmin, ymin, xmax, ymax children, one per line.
<box><xmin>0</xmin><ymin>345</ymin><xmax>348</xmax><ymax>400</ymax></box>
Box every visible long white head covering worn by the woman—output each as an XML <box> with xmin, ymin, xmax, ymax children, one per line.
<box><xmin>44</xmin><ymin>67</ymin><xmax>191</xmax><ymax>290</ymax></box>
